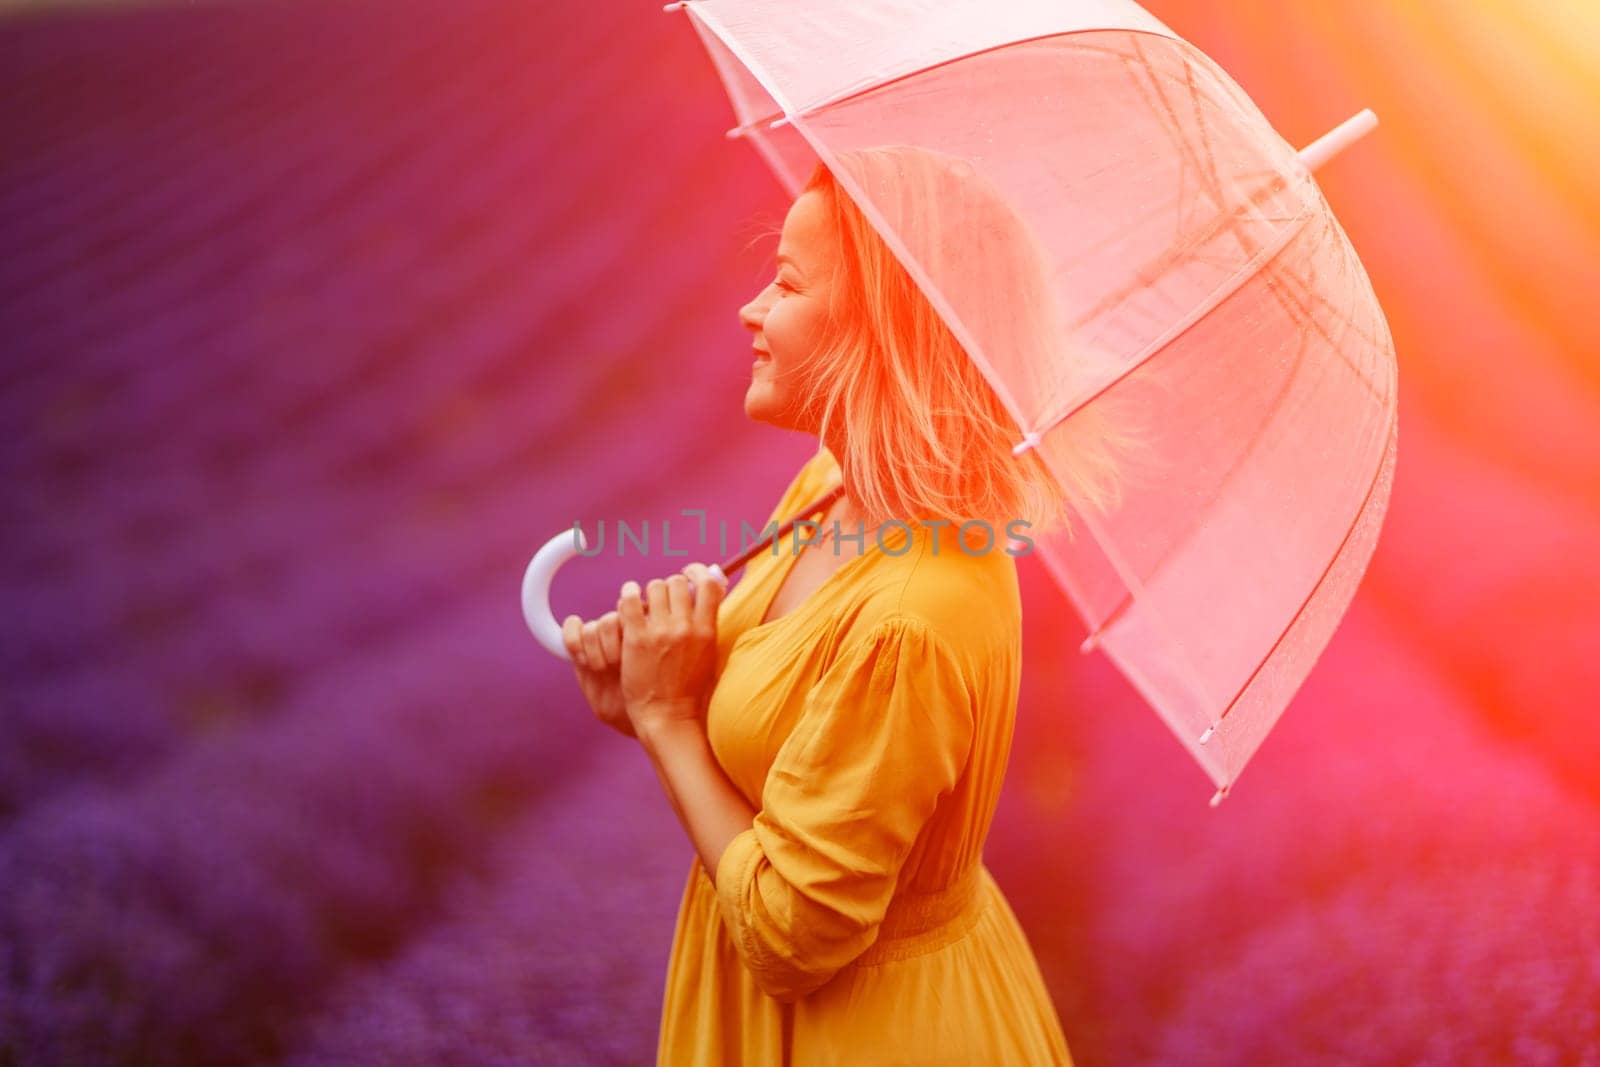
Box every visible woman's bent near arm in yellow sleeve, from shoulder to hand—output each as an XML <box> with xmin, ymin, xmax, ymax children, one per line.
<box><xmin>604</xmin><ymin>563</ymin><xmax>974</xmax><ymax>1001</ymax></box>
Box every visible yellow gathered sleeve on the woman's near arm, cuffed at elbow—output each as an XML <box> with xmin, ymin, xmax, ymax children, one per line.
<box><xmin>715</xmin><ymin>617</ymin><xmax>973</xmax><ymax>1001</ymax></box>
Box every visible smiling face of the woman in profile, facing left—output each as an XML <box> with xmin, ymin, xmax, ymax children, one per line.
<box><xmin>739</xmin><ymin>189</ymin><xmax>838</xmax><ymax>430</ymax></box>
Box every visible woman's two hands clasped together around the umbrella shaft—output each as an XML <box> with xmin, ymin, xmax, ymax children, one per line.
<box><xmin>562</xmin><ymin>563</ymin><xmax>726</xmax><ymax>737</ymax></box>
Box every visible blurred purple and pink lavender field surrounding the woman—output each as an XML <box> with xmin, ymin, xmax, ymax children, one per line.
<box><xmin>0</xmin><ymin>0</ymin><xmax>1600</xmax><ymax>1067</ymax></box>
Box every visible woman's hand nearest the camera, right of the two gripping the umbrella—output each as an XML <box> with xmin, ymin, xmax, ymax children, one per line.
<box><xmin>616</xmin><ymin>563</ymin><xmax>726</xmax><ymax>737</ymax></box>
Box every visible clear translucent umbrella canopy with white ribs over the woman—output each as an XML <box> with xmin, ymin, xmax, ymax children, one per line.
<box><xmin>667</xmin><ymin>0</ymin><xmax>1397</xmax><ymax>803</ymax></box>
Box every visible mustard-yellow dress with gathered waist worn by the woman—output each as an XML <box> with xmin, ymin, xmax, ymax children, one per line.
<box><xmin>658</xmin><ymin>448</ymin><xmax>1070</xmax><ymax>1067</ymax></box>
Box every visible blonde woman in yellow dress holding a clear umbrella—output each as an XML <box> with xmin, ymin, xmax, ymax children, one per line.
<box><xmin>563</xmin><ymin>149</ymin><xmax>1126</xmax><ymax>1065</ymax></box>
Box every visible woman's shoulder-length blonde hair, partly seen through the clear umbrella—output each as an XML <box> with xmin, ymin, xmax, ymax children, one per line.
<box><xmin>777</xmin><ymin>146</ymin><xmax>1133</xmax><ymax>536</ymax></box>
